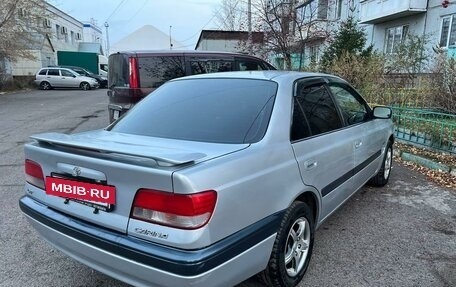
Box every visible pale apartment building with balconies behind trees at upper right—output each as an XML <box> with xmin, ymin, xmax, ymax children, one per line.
<box><xmin>272</xmin><ymin>0</ymin><xmax>456</xmax><ymax>69</ymax></box>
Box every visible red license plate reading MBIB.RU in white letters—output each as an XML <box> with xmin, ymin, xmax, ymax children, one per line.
<box><xmin>46</xmin><ymin>176</ymin><xmax>116</xmax><ymax>209</ymax></box>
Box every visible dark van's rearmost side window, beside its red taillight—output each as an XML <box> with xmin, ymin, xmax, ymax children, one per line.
<box><xmin>137</xmin><ymin>56</ymin><xmax>185</xmax><ymax>88</ymax></box>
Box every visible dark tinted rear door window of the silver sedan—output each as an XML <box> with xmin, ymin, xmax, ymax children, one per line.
<box><xmin>291</xmin><ymin>80</ymin><xmax>342</xmax><ymax>140</ymax></box>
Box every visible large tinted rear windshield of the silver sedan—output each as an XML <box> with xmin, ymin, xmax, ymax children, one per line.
<box><xmin>111</xmin><ymin>79</ymin><xmax>277</xmax><ymax>143</ymax></box>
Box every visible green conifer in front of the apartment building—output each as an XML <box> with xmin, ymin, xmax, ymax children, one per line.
<box><xmin>321</xmin><ymin>17</ymin><xmax>373</xmax><ymax>71</ymax></box>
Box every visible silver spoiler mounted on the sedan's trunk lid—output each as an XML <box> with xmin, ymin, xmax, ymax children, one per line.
<box><xmin>30</xmin><ymin>133</ymin><xmax>206</xmax><ymax>166</ymax></box>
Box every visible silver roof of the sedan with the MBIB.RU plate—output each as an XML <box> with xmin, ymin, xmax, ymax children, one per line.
<box><xmin>171</xmin><ymin>70</ymin><xmax>345</xmax><ymax>82</ymax></box>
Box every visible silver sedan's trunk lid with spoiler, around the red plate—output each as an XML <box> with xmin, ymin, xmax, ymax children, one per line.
<box><xmin>25</xmin><ymin>130</ymin><xmax>248</xmax><ymax>233</ymax></box>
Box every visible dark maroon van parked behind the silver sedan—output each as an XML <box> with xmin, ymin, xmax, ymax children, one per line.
<box><xmin>108</xmin><ymin>51</ymin><xmax>275</xmax><ymax>122</ymax></box>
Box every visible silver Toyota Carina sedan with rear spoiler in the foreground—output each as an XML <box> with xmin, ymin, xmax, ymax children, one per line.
<box><xmin>20</xmin><ymin>71</ymin><xmax>394</xmax><ymax>286</ymax></box>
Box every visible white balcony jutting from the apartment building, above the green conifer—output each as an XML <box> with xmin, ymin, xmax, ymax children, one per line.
<box><xmin>361</xmin><ymin>0</ymin><xmax>427</xmax><ymax>24</ymax></box>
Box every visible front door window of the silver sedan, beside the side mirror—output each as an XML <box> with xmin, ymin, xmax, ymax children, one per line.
<box><xmin>329</xmin><ymin>84</ymin><xmax>369</xmax><ymax>125</ymax></box>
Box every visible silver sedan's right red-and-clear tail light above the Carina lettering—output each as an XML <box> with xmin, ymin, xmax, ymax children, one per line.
<box><xmin>131</xmin><ymin>189</ymin><xmax>217</xmax><ymax>229</ymax></box>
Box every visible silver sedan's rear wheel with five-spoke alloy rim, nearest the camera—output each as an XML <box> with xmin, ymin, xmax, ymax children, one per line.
<box><xmin>260</xmin><ymin>201</ymin><xmax>315</xmax><ymax>287</ymax></box>
